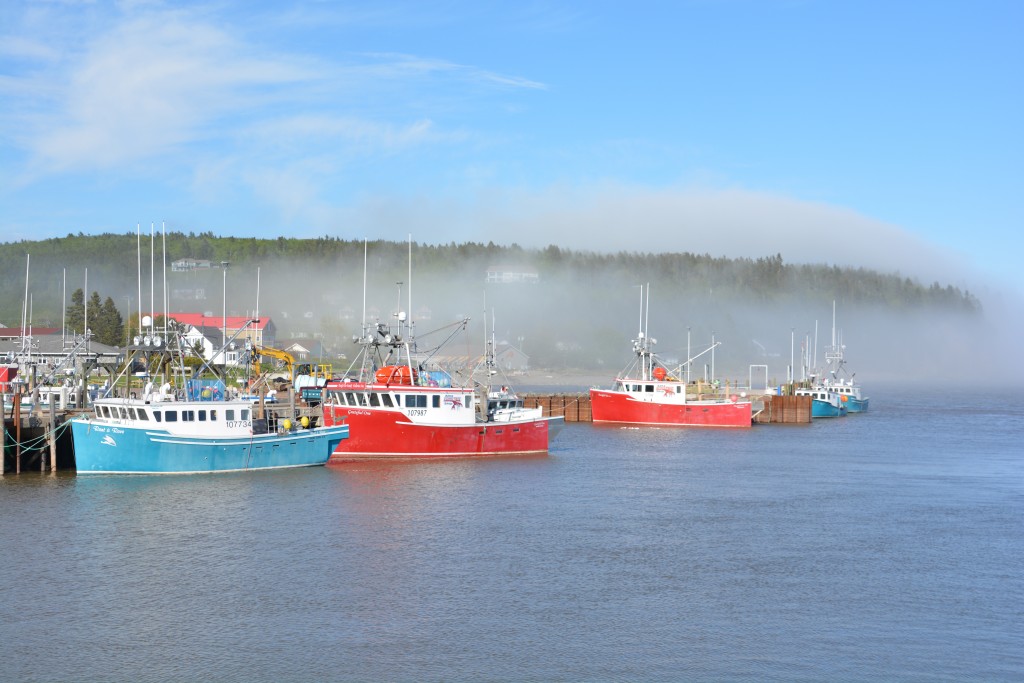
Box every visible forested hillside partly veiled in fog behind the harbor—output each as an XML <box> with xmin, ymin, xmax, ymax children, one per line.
<box><xmin>0</xmin><ymin>231</ymin><xmax>981</xmax><ymax>374</ymax></box>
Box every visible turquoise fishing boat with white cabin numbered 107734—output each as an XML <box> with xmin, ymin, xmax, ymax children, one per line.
<box><xmin>71</xmin><ymin>382</ymin><xmax>348</xmax><ymax>474</ymax></box>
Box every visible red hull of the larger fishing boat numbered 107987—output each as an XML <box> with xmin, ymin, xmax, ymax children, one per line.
<box><xmin>325</xmin><ymin>405</ymin><xmax>551</xmax><ymax>463</ymax></box>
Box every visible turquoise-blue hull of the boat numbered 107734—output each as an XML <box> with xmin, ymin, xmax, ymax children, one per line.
<box><xmin>71</xmin><ymin>419</ymin><xmax>348</xmax><ymax>474</ymax></box>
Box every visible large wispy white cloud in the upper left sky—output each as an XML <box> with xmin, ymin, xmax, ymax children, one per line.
<box><xmin>6</xmin><ymin>5</ymin><xmax>544</xmax><ymax>184</ymax></box>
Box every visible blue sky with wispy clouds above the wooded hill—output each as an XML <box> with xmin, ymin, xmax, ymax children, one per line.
<box><xmin>0</xmin><ymin>0</ymin><xmax>1024</xmax><ymax>293</ymax></box>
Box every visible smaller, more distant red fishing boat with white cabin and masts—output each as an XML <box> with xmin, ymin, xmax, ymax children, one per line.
<box><xmin>590</xmin><ymin>289</ymin><xmax>752</xmax><ymax>427</ymax></box>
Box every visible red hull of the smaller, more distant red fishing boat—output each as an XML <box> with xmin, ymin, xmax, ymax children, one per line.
<box><xmin>590</xmin><ymin>389</ymin><xmax>751</xmax><ymax>427</ymax></box>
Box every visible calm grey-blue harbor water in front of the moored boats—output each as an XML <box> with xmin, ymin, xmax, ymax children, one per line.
<box><xmin>0</xmin><ymin>387</ymin><xmax>1024</xmax><ymax>681</ymax></box>
